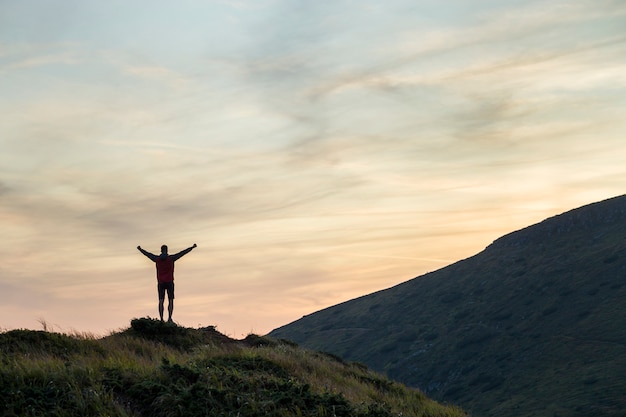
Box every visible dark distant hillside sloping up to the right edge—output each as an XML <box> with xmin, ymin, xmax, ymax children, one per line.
<box><xmin>270</xmin><ymin>196</ymin><xmax>626</xmax><ymax>417</ymax></box>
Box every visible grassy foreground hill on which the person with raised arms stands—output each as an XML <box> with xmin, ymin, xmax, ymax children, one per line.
<box><xmin>0</xmin><ymin>319</ymin><xmax>465</xmax><ymax>417</ymax></box>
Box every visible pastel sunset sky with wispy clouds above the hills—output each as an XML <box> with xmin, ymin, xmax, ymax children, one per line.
<box><xmin>0</xmin><ymin>0</ymin><xmax>626</xmax><ymax>338</ymax></box>
